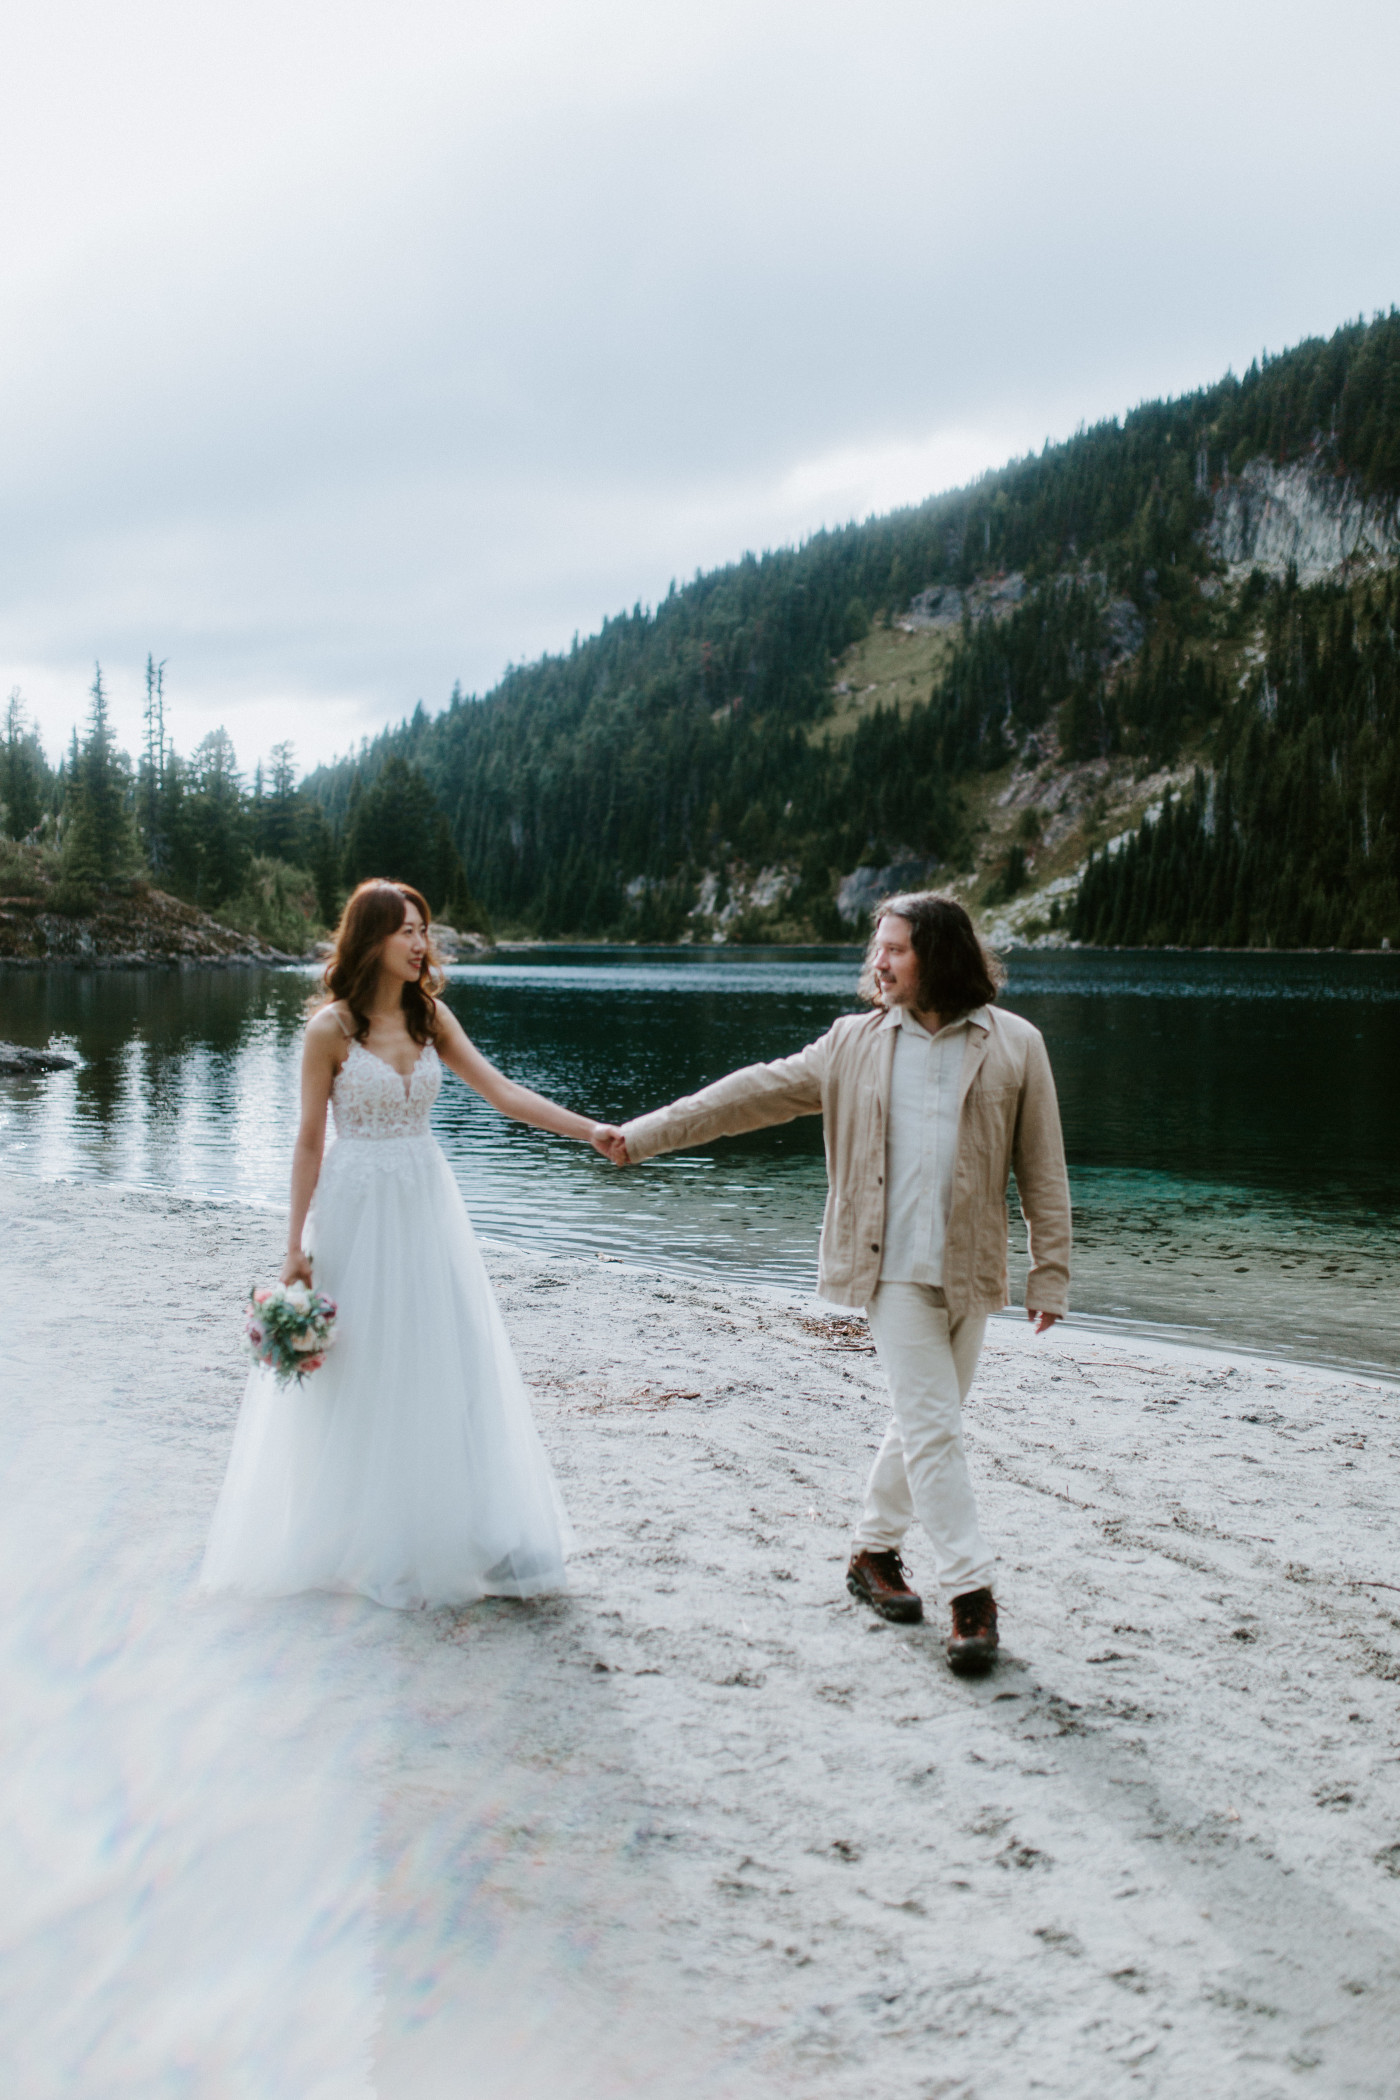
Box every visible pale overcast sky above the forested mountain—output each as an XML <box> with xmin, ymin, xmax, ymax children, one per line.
<box><xmin>0</xmin><ymin>0</ymin><xmax>1400</xmax><ymax>769</ymax></box>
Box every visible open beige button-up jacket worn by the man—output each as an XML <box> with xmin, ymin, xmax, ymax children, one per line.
<box><xmin>623</xmin><ymin>1006</ymin><xmax>1070</xmax><ymax>1319</ymax></box>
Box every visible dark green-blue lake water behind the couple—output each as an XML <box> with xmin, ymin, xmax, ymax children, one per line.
<box><xmin>0</xmin><ymin>949</ymin><xmax>1400</xmax><ymax>1373</ymax></box>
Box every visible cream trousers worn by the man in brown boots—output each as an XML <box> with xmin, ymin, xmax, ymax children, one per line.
<box><xmin>854</xmin><ymin>1283</ymin><xmax>993</xmax><ymax>1600</ymax></box>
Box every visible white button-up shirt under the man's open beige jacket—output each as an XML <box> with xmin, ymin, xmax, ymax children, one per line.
<box><xmin>879</xmin><ymin>1006</ymin><xmax>978</xmax><ymax>1285</ymax></box>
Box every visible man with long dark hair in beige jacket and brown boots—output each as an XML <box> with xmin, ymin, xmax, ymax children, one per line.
<box><xmin>611</xmin><ymin>890</ymin><xmax>1070</xmax><ymax>1672</ymax></box>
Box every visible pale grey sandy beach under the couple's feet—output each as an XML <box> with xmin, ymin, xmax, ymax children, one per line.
<box><xmin>0</xmin><ymin>1176</ymin><xmax>1400</xmax><ymax>2100</ymax></box>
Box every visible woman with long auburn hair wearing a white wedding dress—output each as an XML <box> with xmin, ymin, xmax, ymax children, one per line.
<box><xmin>199</xmin><ymin>882</ymin><xmax>613</xmax><ymax>1607</ymax></box>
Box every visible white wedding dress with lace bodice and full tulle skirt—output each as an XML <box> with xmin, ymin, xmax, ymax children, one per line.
<box><xmin>199</xmin><ymin>1042</ymin><xmax>573</xmax><ymax>1607</ymax></box>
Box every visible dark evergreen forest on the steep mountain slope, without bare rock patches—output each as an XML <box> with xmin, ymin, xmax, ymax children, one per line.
<box><xmin>306</xmin><ymin>311</ymin><xmax>1400</xmax><ymax>943</ymax></box>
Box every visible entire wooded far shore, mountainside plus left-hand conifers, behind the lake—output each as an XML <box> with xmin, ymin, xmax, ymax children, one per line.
<box><xmin>0</xmin><ymin>311</ymin><xmax>1400</xmax><ymax>947</ymax></box>
